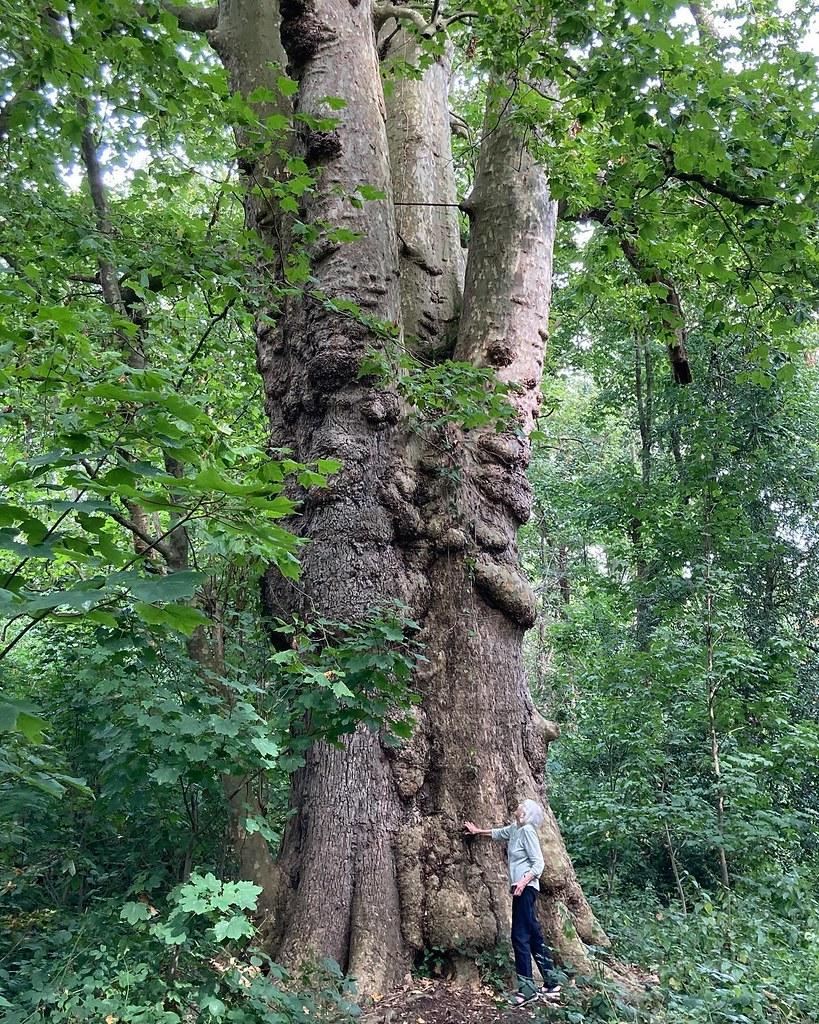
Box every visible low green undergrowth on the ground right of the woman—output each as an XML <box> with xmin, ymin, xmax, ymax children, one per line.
<box><xmin>549</xmin><ymin>870</ymin><xmax>819</xmax><ymax>1024</ymax></box>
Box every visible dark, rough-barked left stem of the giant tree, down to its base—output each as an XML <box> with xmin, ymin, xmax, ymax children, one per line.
<box><xmin>253</xmin><ymin>0</ymin><xmax>410</xmax><ymax>987</ymax></box>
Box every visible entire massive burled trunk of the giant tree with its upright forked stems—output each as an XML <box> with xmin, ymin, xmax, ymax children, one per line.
<box><xmin>210</xmin><ymin>0</ymin><xmax>605</xmax><ymax>992</ymax></box>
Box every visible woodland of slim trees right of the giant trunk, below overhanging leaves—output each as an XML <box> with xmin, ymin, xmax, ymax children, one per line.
<box><xmin>522</xmin><ymin>226</ymin><xmax>819</xmax><ymax>1021</ymax></box>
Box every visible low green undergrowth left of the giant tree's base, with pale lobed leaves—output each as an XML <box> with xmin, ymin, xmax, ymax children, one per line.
<box><xmin>0</xmin><ymin>872</ymin><xmax>359</xmax><ymax>1024</ymax></box>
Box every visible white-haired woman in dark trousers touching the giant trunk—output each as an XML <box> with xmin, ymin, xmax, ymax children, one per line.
<box><xmin>464</xmin><ymin>800</ymin><xmax>560</xmax><ymax>1006</ymax></box>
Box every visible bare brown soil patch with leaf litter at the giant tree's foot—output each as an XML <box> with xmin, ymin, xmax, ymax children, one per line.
<box><xmin>361</xmin><ymin>978</ymin><xmax>559</xmax><ymax>1024</ymax></box>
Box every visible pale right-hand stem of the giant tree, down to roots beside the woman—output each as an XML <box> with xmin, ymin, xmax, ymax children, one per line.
<box><xmin>434</xmin><ymin>86</ymin><xmax>605</xmax><ymax>964</ymax></box>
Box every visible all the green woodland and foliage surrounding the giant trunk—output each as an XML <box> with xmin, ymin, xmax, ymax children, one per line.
<box><xmin>0</xmin><ymin>0</ymin><xmax>819</xmax><ymax>1024</ymax></box>
